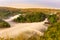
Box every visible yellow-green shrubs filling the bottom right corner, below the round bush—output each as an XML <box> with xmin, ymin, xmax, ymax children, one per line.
<box><xmin>41</xmin><ymin>23</ymin><xmax>60</xmax><ymax>40</ymax></box>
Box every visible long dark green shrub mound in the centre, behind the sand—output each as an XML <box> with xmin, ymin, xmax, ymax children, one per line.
<box><xmin>14</xmin><ymin>12</ymin><xmax>46</xmax><ymax>23</ymax></box>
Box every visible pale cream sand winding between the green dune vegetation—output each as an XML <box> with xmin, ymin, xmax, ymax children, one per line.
<box><xmin>0</xmin><ymin>14</ymin><xmax>47</xmax><ymax>38</ymax></box>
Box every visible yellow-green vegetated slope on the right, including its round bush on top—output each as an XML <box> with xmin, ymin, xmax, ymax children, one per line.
<box><xmin>41</xmin><ymin>14</ymin><xmax>60</xmax><ymax>40</ymax></box>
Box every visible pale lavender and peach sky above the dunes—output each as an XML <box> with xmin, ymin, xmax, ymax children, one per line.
<box><xmin>0</xmin><ymin>0</ymin><xmax>60</xmax><ymax>8</ymax></box>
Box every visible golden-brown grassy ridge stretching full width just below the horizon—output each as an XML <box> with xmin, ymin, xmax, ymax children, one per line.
<box><xmin>0</xmin><ymin>7</ymin><xmax>60</xmax><ymax>18</ymax></box>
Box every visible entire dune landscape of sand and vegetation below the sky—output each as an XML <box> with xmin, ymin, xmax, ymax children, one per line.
<box><xmin>0</xmin><ymin>7</ymin><xmax>60</xmax><ymax>40</ymax></box>
